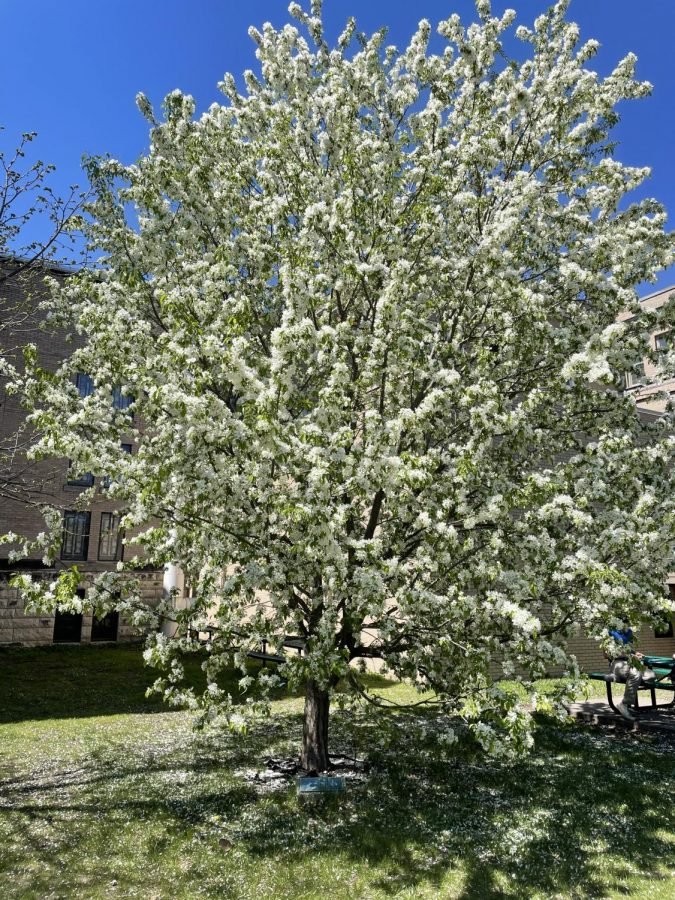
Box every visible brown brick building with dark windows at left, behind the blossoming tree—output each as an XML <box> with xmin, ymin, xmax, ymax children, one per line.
<box><xmin>0</xmin><ymin>260</ymin><xmax>163</xmax><ymax>646</ymax></box>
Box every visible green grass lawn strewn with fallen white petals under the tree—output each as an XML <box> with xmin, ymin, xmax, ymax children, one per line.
<box><xmin>0</xmin><ymin>647</ymin><xmax>675</xmax><ymax>900</ymax></box>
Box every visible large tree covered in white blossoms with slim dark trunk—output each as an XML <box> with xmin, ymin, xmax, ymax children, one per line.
<box><xmin>13</xmin><ymin>0</ymin><xmax>675</xmax><ymax>769</ymax></box>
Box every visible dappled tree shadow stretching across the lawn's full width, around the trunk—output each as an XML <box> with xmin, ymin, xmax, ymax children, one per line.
<box><xmin>0</xmin><ymin>714</ymin><xmax>674</xmax><ymax>900</ymax></box>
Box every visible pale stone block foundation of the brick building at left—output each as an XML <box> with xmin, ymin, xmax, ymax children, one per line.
<box><xmin>0</xmin><ymin>569</ymin><xmax>163</xmax><ymax>647</ymax></box>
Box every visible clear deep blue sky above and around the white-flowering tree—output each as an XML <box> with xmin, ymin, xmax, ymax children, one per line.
<box><xmin>0</xmin><ymin>0</ymin><xmax>675</xmax><ymax>286</ymax></box>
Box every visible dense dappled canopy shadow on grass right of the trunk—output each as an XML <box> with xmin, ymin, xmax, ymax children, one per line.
<box><xmin>230</xmin><ymin>724</ymin><xmax>675</xmax><ymax>898</ymax></box>
